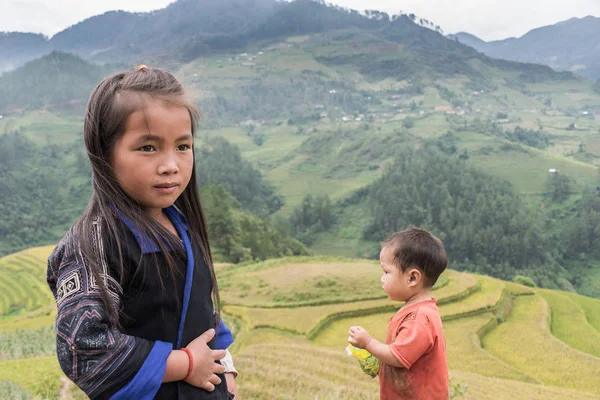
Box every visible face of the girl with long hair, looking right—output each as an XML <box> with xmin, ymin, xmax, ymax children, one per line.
<box><xmin>112</xmin><ymin>99</ymin><xmax>194</xmax><ymax>218</ymax></box>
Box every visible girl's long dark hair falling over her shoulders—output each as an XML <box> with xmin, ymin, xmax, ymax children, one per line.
<box><xmin>73</xmin><ymin>67</ymin><xmax>220</xmax><ymax>327</ymax></box>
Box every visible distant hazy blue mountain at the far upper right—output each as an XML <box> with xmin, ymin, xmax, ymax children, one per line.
<box><xmin>451</xmin><ymin>16</ymin><xmax>600</xmax><ymax>79</ymax></box>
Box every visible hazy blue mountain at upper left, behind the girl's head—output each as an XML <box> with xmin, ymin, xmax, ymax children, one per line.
<box><xmin>0</xmin><ymin>0</ymin><xmax>285</xmax><ymax>71</ymax></box>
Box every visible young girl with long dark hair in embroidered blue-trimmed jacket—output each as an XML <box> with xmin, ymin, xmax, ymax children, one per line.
<box><xmin>48</xmin><ymin>66</ymin><xmax>236</xmax><ymax>400</ymax></box>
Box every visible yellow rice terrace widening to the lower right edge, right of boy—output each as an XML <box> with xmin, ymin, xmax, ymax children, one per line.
<box><xmin>483</xmin><ymin>295</ymin><xmax>600</xmax><ymax>395</ymax></box>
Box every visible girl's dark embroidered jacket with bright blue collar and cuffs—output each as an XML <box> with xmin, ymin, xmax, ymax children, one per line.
<box><xmin>48</xmin><ymin>207</ymin><xmax>233</xmax><ymax>400</ymax></box>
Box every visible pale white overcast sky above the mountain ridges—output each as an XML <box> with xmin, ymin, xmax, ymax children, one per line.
<box><xmin>0</xmin><ymin>0</ymin><xmax>600</xmax><ymax>41</ymax></box>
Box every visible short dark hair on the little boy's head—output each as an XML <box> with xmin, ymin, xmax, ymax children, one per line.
<box><xmin>381</xmin><ymin>226</ymin><xmax>448</xmax><ymax>287</ymax></box>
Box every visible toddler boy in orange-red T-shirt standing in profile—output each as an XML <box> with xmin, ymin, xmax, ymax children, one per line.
<box><xmin>348</xmin><ymin>226</ymin><xmax>448</xmax><ymax>400</ymax></box>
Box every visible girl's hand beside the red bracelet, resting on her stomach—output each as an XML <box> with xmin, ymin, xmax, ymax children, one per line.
<box><xmin>185</xmin><ymin>329</ymin><xmax>225</xmax><ymax>392</ymax></box>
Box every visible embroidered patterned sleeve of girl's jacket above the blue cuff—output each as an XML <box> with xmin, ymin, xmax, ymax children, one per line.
<box><xmin>48</xmin><ymin>220</ymin><xmax>136</xmax><ymax>398</ymax></box>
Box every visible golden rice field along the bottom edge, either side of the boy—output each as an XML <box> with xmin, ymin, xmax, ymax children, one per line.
<box><xmin>234</xmin><ymin>328</ymin><xmax>597</xmax><ymax>400</ymax></box>
